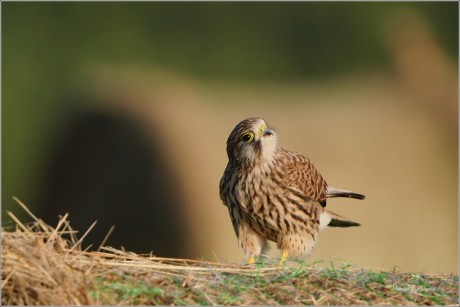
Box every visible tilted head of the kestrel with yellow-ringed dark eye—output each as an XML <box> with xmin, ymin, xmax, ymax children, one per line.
<box><xmin>227</xmin><ymin>117</ymin><xmax>278</xmax><ymax>163</ymax></box>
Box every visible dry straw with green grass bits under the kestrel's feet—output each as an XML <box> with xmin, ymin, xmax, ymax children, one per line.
<box><xmin>2</xmin><ymin>201</ymin><xmax>458</xmax><ymax>305</ymax></box>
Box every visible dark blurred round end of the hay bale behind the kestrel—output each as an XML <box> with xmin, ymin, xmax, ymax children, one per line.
<box><xmin>39</xmin><ymin>106</ymin><xmax>185</xmax><ymax>257</ymax></box>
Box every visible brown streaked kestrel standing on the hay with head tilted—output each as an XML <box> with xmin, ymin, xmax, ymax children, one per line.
<box><xmin>219</xmin><ymin>118</ymin><xmax>365</xmax><ymax>264</ymax></box>
